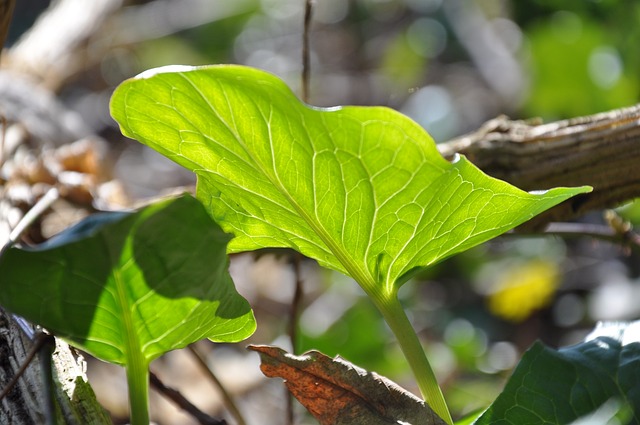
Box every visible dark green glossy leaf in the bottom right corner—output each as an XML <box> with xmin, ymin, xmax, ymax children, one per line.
<box><xmin>474</xmin><ymin>322</ymin><xmax>640</xmax><ymax>425</ymax></box>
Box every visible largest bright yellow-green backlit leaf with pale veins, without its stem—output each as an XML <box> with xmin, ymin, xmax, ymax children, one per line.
<box><xmin>111</xmin><ymin>66</ymin><xmax>588</xmax><ymax>296</ymax></box>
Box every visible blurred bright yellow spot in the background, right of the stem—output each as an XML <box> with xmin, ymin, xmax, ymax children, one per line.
<box><xmin>489</xmin><ymin>260</ymin><xmax>560</xmax><ymax>322</ymax></box>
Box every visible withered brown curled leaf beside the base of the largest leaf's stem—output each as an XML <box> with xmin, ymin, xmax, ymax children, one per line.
<box><xmin>249</xmin><ymin>345</ymin><xmax>445</xmax><ymax>425</ymax></box>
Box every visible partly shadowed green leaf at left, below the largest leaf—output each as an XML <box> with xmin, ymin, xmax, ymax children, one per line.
<box><xmin>0</xmin><ymin>195</ymin><xmax>255</xmax><ymax>365</ymax></box>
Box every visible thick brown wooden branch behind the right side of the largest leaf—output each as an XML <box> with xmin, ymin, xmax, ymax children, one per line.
<box><xmin>439</xmin><ymin>104</ymin><xmax>640</xmax><ymax>230</ymax></box>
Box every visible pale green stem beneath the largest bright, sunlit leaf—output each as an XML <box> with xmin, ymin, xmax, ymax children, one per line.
<box><xmin>369</xmin><ymin>294</ymin><xmax>453</xmax><ymax>425</ymax></box>
